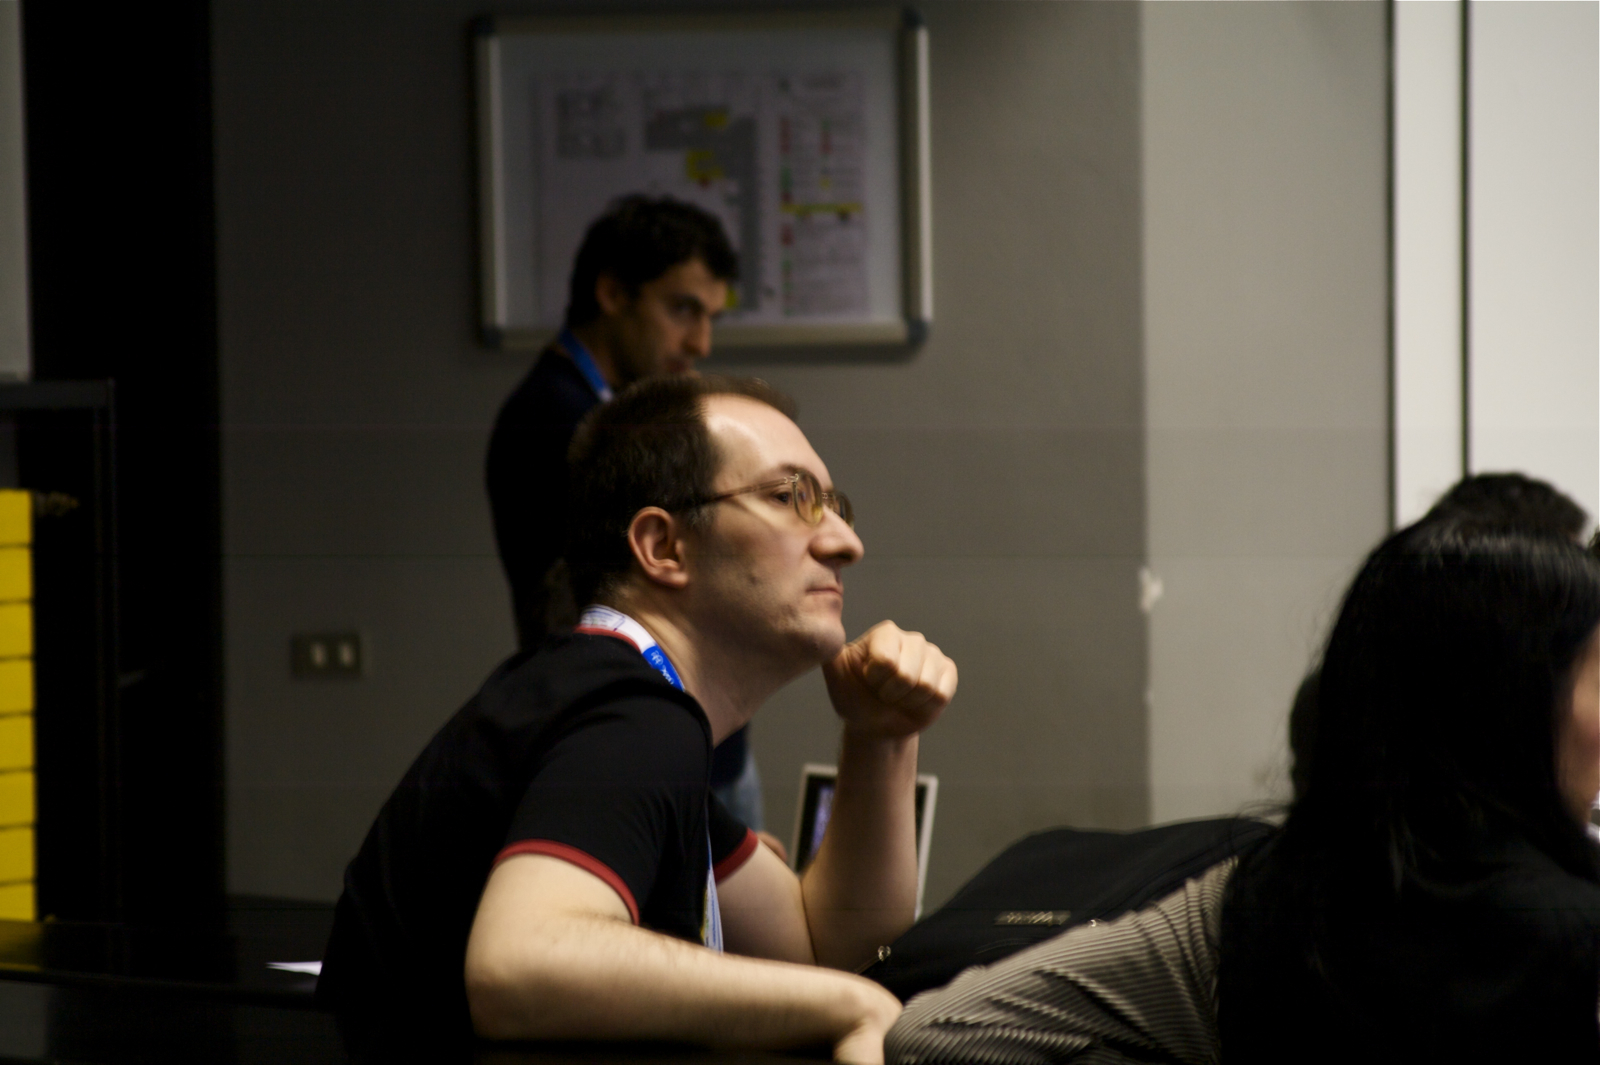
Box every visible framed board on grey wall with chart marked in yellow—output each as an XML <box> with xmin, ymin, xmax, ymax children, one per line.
<box><xmin>477</xmin><ymin>8</ymin><xmax>933</xmax><ymax>347</ymax></box>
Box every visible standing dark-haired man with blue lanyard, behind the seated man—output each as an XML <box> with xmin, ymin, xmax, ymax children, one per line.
<box><xmin>485</xmin><ymin>195</ymin><xmax>776</xmax><ymax>843</ymax></box>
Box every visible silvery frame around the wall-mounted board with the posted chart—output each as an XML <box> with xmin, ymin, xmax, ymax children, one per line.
<box><xmin>474</xmin><ymin>8</ymin><xmax>933</xmax><ymax>350</ymax></box>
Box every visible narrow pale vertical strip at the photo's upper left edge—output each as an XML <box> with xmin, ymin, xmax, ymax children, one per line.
<box><xmin>0</xmin><ymin>0</ymin><xmax>30</xmax><ymax>381</ymax></box>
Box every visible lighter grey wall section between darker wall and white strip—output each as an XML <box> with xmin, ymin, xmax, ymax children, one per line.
<box><xmin>1128</xmin><ymin>2</ymin><xmax>1390</xmax><ymax>822</ymax></box>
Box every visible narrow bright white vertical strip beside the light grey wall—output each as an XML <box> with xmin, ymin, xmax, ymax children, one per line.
<box><xmin>1394</xmin><ymin>0</ymin><xmax>1466</xmax><ymax>525</ymax></box>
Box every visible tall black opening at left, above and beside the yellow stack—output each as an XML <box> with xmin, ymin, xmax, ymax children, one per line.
<box><xmin>22</xmin><ymin>0</ymin><xmax>224</xmax><ymax>923</ymax></box>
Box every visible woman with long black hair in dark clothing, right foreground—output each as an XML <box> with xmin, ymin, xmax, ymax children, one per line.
<box><xmin>1218</xmin><ymin>521</ymin><xmax>1600</xmax><ymax>1065</ymax></box>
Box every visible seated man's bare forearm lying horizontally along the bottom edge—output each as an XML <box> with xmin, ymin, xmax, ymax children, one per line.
<box><xmin>466</xmin><ymin>915</ymin><xmax>899</xmax><ymax>1062</ymax></box>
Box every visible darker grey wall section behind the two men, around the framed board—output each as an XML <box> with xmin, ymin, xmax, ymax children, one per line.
<box><xmin>214</xmin><ymin>0</ymin><xmax>1147</xmax><ymax>905</ymax></box>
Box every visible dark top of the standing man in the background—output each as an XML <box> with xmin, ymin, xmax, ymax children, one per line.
<box><xmin>485</xmin><ymin>344</ymin><xmax>600</xmax><ymax>651</ymax></box>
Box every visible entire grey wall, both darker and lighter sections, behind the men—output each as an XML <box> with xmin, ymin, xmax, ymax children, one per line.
<box><xmin>214</xmin><ymin>0</ymin><xmax>1386</xmax><ymax>905</ymax></box>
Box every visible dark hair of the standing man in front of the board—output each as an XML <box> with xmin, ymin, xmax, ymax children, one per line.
<box><xmin>566</xmin><ymin>195</ymin><xmax>739</xmax><ymax>328</ymax></box>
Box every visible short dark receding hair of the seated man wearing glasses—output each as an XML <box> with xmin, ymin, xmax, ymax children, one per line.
<box><xmin>566</xmin><ymin>374</ymin><xmax>795</xmax><ymax>606</ymax></box>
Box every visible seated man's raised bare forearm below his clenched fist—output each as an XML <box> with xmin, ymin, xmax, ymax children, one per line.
<box><xmin>802</xmin><ymin>728</ymin><xmax>917</xmax><ymax>969</ymax></box>
